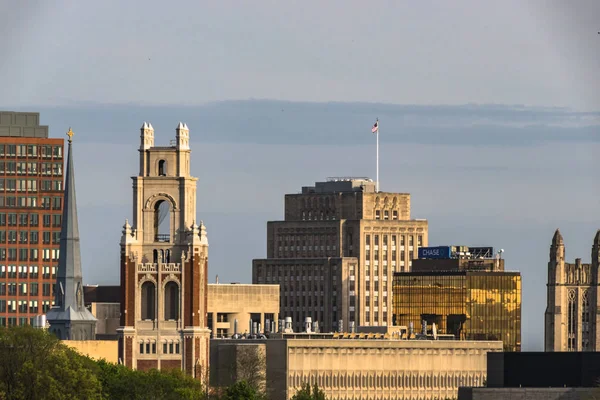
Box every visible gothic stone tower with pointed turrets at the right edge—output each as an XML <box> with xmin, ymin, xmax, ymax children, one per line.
<box><xmin>544</xmin><ymin>229</ymin><xmax>600</xmax><ymax>351</ymax></box>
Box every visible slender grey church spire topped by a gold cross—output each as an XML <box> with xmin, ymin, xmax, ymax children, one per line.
<box><xmin>46</xmin><ymin>129</ymin><xmax>96</xmax><ymax>340</ymax></box>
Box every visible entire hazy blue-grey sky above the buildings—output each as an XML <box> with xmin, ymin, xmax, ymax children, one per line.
<box><xmin>0</xmin><ymin>0</ymin><xmax>600</xmax><ymax>350</ymax></box>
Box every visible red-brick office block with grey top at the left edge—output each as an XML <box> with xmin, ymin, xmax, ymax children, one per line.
<box><xmin>0</xmin><ymin>111</ymin><xmax>64</xmax><ymax>326</ymax></box>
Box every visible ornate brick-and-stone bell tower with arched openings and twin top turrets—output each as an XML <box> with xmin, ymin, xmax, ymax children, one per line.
<box><xmin>118</xmin><ymin>123</ymin><xmax>210</xmax><ymax>379</ymax></box>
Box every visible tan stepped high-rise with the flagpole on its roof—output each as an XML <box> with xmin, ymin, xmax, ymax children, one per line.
<box><xmin>252</xmin><ymin>178</ymin><xmax>428</xmax><ymax>332</ymax></box>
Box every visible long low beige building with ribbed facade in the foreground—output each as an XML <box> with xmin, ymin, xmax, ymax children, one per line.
<box><xmin>211</xmin><ymin>334</ymin><xmax>502</xmax><ymax>400</ymax></box>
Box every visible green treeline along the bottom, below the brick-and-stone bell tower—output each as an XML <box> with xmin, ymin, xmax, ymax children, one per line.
<box><xmin>0</xmin><ymin>326</ymin><xmax>325</xmax><ymax>400</ymax></box>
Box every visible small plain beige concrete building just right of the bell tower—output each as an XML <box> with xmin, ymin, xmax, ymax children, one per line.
<box><xmin>207</xmin><ymin>283</ymin><xmax>279</xmax><ymax>338</ymax></box>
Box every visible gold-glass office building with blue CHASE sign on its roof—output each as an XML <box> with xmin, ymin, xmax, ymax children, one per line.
<box><xmin>393</xmin><ymin>245</ymin><xmax>521</xmax><ymax>351</ymax></box>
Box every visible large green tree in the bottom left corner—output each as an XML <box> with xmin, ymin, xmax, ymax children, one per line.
<box><xmin>0</xmin><ymin>326</ymin><xmax>103</xmax><ymax>400</ymax></box>
